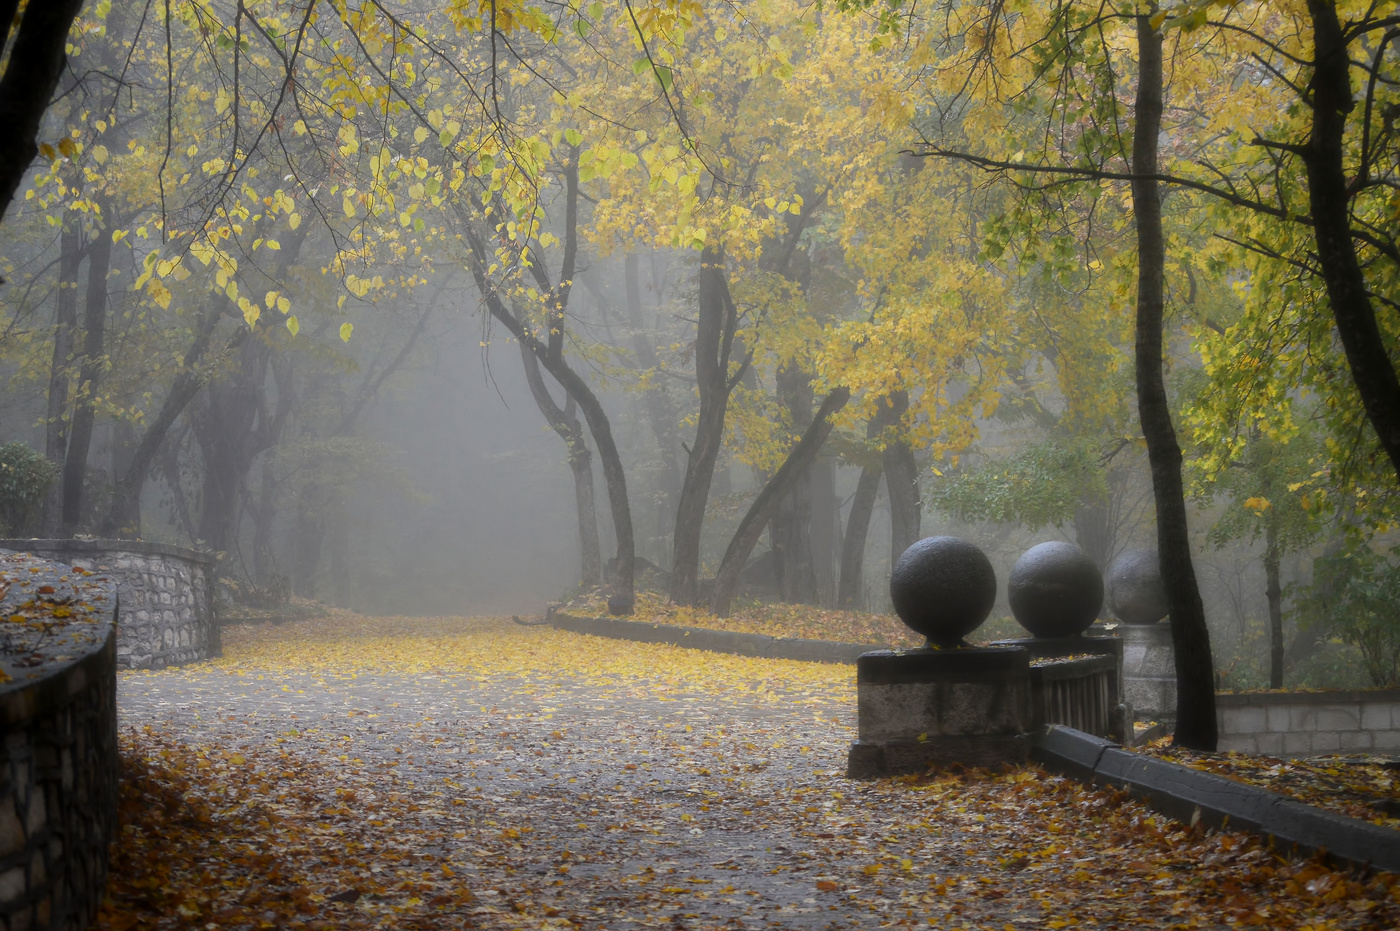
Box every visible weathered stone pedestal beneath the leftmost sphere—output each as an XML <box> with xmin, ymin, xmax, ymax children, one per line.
<box><xmin>847</xmin><ymin>647</ymin><xmax>1033</xmax><ymax>778</ymax></box>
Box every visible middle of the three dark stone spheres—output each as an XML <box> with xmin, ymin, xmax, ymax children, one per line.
<box><xmin>1007</xmin><ymin>540</ymin><xmax>1103</xmax><ymax>638</ymax></box>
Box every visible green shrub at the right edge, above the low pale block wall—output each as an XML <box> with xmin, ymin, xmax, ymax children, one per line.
<box><xmin>1298</xmin><ymin>546</ymin><xmax>1400</xmax><ymax>686</ymax></box>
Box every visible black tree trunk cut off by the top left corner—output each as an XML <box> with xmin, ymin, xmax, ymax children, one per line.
<box><xmin>0</xmin><ymin>0</ymin><xmax>83</xmax><ymax>218</ymax></box>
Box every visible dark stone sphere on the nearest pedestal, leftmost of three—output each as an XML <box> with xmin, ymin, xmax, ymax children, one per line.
<box><xmin>889</xmin><ymin>536</ymin><xmax>997</xmax><ymax>647</ymax></box>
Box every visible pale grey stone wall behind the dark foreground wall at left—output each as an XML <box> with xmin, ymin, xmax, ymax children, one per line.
<box><xmin>0</xmin><ymin>540</ymin><xmax>223</xmax><ymax>669</ymax></box>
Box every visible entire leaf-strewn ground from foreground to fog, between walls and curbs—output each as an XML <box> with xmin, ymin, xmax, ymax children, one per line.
<box><xmin>98</xmin><ymin>615</ymin><xmax>1400</xmax><ymax>931</ymax></box>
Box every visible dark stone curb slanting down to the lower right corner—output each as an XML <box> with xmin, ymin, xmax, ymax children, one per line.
<box><xmin>1030</xmin><ymin>724</ymin><xmax>1400</xmax><ymax>872</ymax></box>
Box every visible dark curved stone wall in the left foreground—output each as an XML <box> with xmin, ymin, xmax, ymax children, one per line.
<box><xmin>0</xmin><ymin>557</ymin><xmax>119</xmax><ymax>931</ymax></box>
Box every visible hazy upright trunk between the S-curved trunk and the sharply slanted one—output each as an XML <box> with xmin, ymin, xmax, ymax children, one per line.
<box><xmin>671</xmin><ymin>248</ymin><xmax>738</xmax><ymax>605</ymax></box>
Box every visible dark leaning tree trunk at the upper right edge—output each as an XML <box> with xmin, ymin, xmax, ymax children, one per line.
<box><xmin>1303</xmin><ymin>0</ymin><xmax>1400</xmax><ymax>479</ymax></box>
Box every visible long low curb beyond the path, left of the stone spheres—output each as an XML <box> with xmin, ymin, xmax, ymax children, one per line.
<box><xmin>547</xmin><ymin>612</ymin><xmax>886</xmax><ymax>665</ymax></box>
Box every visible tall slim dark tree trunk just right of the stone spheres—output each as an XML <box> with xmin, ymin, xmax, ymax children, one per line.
<box><xmin>1133</xmin><ymin>10</ymin><xmax>1217</xmax><ymax>750</ymax></box>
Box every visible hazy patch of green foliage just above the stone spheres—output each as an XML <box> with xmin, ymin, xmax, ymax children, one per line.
<box><xmin>928</xmin><ymin>440</ymin><xmax>1109</xmax><ymax>529</ymax></box>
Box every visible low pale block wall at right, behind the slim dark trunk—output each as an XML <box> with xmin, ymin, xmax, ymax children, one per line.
<box><xmin>1215</xmin><ymin>689</ymin><xmax>1400</xmax><ymax>757</ymax></box>
